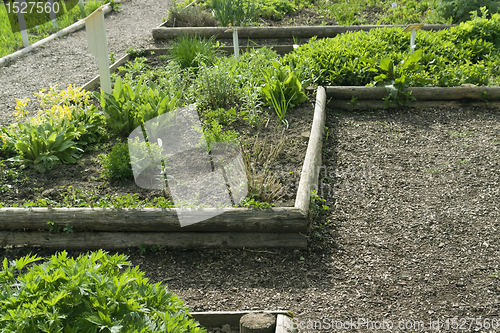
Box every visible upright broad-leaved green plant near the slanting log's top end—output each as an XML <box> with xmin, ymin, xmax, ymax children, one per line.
<box><xmin>262</xmin><ymin>62</ymin><xmax>307</xmax><ymax>127</ymax></box>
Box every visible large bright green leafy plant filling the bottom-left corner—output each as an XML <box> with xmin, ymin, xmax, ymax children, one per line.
<box><xmin>0</xmin><ymin>250</ymin><xmax>206</xmax><ymax>333</ymax></box>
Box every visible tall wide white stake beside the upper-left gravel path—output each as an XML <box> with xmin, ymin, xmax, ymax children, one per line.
<box><xmin>85</xmin><ymin>6</ymin><xmax>111</xmax><ymax>94</ymax></box>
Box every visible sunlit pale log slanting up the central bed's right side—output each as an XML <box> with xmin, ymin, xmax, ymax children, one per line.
<box><xmin>295</xmin><ymin>87</ymin><xmax>326</xmax><ymax>212</ymax></box>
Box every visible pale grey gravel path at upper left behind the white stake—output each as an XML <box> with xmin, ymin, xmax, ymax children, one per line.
<box><xmin>0</xmin><ymin>0</ymin><xmax>171</xmax><ymax>126</ymax></box>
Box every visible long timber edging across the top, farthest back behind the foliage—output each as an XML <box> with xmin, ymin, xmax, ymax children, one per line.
<box><xmin>153</xmin><ymin>23</ymin><xmax>456</xmax><ymax>39</ymax></box>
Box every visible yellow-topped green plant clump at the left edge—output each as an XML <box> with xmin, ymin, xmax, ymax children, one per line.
<box><xmin>0</xmin><ymin>85</ymin><xmax>104</xmax><ymax>173</ymax></box>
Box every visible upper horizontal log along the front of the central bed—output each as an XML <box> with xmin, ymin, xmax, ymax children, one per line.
<box><xmin>0</xmin><ymin>207</ymin><xmax>307</xmax><ymax>233</ymax></box>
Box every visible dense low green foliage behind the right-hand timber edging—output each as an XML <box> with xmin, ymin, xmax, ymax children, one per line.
<box><xmin>281</xmin><ymin>14</ymin><xmax>500</xmax><ymax>87</ymax></box>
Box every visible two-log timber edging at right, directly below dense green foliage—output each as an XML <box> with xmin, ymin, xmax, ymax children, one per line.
<box><xmin>325</xmin><ymin>85</ymin><xmax>500</xmax><ymax>110</ymax></box>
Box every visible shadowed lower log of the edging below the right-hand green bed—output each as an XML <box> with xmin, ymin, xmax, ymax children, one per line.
<box><xmin>330</xmin><ymin>100</ymin><xmax>500</xmax><ymax>110</ymax></box>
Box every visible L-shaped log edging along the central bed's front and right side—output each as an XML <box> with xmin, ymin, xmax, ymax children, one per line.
<box><xmin>0</xmin><ymin>81</ymin><xmax>326</xmax><ymax>250</ymax></box>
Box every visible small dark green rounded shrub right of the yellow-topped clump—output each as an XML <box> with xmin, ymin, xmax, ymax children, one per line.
<box><xmin>99</xmin><ymin>142</ymin><xmax>134</xmax><ymax>180</ymax></box>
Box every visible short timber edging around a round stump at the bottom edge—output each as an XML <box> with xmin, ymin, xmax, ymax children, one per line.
<box><xmin>190</xmin><ymin>310</ymin><xmax>297</xmax><ymax>333</ymax></box>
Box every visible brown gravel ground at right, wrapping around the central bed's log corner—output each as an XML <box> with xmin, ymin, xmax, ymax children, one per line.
<box><xmin>2</xmin><ymin>105</ymin><xmax>500</xmax><ymax>332</ymax></box>
